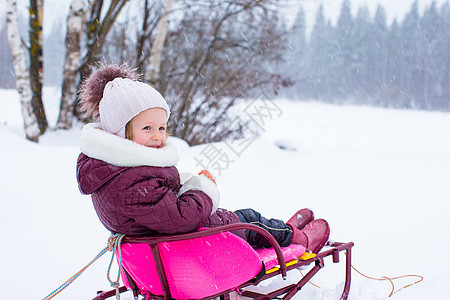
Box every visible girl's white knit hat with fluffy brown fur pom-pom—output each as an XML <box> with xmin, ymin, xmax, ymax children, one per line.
<box><xmin>80</xmin><ymin>65</ymin><xmax>170</xmax><ymax>138</ymax></box>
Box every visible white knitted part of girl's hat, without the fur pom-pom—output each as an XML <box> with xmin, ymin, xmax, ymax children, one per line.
<box><xmin>99</xmin><ymin>78</ymin><xmax>170</xmax><ymax>138</ymax></box>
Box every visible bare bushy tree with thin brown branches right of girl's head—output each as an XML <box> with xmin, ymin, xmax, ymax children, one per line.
<box><xmin>157</xmin><ymin>0</ymin><xmax>287</xmax><ymax>145</ymax></box>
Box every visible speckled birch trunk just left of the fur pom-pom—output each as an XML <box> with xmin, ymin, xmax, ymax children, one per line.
<box><xmin>57</xmin><ymin>0</ymin><xmax>84</xmax><ymax>129</ymax></box>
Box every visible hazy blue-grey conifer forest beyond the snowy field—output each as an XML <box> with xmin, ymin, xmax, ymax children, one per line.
<box><xmin>280</xmin><ymin>0</ymin><xmax>450</xmax><ymax>111</ymax></box>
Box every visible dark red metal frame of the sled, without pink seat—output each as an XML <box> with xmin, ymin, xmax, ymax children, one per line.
<box><xmin>93</xmin><ymin>223</ymin><xmax>354</xmax><ymax>300</ymax></box>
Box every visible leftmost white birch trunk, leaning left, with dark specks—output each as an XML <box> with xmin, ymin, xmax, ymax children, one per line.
<box><xmin>6</xmin><ymin>0</ymin><xmax>40</xmax><ymax>142</ymax></box>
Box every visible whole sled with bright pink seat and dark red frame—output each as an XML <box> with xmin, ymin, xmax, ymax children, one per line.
<box><xmin>93</xmin><ymin>223</ymin><xmax>353</xmax><ymax>300</ymax></box>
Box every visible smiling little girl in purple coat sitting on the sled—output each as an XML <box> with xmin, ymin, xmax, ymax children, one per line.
<box><xmin>77</xmin><ymin>65</ymin><xmax>329</xmax><ymax>253</ymax></box>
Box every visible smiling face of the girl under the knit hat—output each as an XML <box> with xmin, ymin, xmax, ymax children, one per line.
<box><xmin>126</xmin><ymin>108</ymin><xmax>167</xmax><ymax>148</ymax></box>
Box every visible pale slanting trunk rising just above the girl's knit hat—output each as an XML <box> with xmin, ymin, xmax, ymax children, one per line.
<box><xmin>145</xmin><ymin>0</ymin><xmax>175</xmax><ymax>85</ymax></box>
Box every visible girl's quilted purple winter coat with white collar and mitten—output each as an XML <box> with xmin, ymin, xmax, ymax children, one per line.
<box><xmin>77</xmin><ymin>124</ymin><xmax>239</xmax><ymax>235</ymax></box>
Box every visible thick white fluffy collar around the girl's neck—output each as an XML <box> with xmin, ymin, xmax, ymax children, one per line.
<box><xmin>80</xmin><ymin>123</ymin><xmax>178</xmax><ymax>167</ymax></box>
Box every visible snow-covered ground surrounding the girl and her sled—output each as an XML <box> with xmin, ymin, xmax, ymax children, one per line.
<box><xmin>0</xmin><ymin>89</ymin><xmax>450</xmax><ymax>300</ymax></box>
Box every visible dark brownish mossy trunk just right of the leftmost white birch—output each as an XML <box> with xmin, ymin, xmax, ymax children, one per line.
<box><xmin>29</xmin><ymin>0</ymin><xmax>48</xmax><ymax>134</ymax></box>
